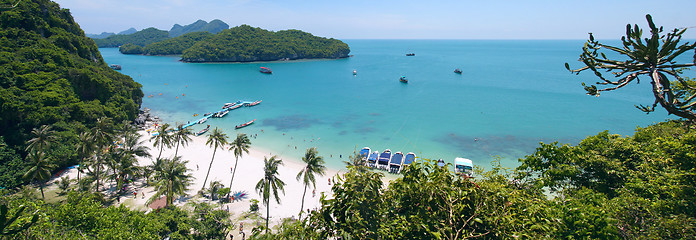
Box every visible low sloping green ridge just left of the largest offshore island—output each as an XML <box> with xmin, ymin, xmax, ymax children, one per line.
<box><xmin>133</xmin><ymin>32</ymin><xmax>213</xmax><ymax>55</ymax></box>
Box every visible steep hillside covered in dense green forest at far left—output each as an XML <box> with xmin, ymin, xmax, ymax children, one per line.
<box><xmin>0</xmin><ymin>0</ymin><xmax>143</xmax><ymax>187</ymax></box>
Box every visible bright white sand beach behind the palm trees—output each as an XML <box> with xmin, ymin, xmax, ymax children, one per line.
<box><xmin>135</xmin><ymin>131</ymin><xmax>345</xmax><ymax>229</ymax></box>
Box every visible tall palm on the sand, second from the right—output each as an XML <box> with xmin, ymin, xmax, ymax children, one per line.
<box><xmin>256</xmin><ymin>156</ymin><xmax>285</xmax><ymax>233</ymax></box>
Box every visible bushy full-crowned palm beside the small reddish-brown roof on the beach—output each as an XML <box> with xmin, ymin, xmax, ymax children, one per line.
<box><xmin>147</xmin><ymin>157</ymin><xmax>193</xmax><ymax>206</ymax></box>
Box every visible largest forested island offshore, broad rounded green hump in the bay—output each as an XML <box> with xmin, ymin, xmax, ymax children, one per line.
<box><xmin>181</xmin><ymin>25</ymin><xmax>350</xmax><ymax>62</ymax></box>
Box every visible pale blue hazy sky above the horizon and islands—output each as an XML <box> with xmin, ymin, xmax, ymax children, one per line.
<box><xmin>55</xmin><ymin>0</ymin><xmax>696</xmax><ymax>39</ymax></box>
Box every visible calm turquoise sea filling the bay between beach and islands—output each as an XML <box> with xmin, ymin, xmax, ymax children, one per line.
<box><xmin>100</xmin><ymin>40</ymin><xmax>668</xmax><ymax>168</ymax></box>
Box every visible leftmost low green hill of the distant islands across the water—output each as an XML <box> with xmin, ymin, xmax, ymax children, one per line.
<box><xmin>94</xmin><ymin>28</ymin><xmax>169</xmax><ymax>47</ymax></box>
